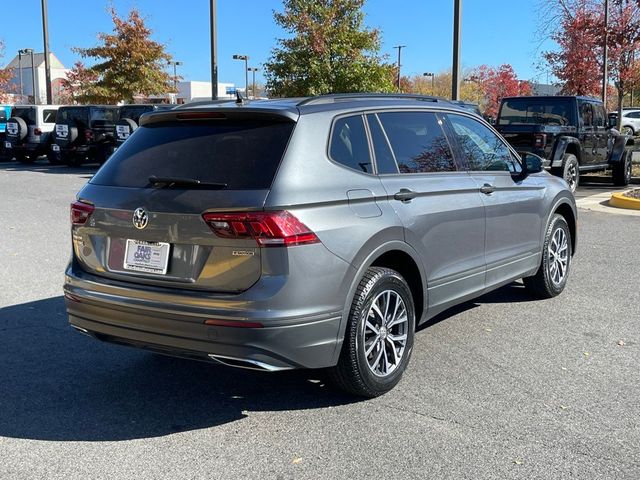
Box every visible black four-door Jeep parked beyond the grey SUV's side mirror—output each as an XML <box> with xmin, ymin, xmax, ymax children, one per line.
<box><xmin>496</xmin><ymin>96</ymin><xmax>635</xmax><ymax>191</ymax></box>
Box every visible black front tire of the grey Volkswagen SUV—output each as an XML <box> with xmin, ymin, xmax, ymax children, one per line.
<box><xmin>522</xmin><ymin>214</ymin><xmax>572</xmax><ymax>298</ymax></box>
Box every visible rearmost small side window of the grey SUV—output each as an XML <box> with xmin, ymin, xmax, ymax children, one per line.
<box><xmin>329</xmin><ymin>115</ymin><xmax>373</xmax><ymax>173</ymax></box>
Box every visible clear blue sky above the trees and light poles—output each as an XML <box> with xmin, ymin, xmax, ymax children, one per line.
<box><xmin>0</xmin><ymin>0</ymin><xmax>553</xmax><ymax>85</ymax></box>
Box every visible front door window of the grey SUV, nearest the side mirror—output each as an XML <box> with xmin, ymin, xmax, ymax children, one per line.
<box><xmin>448</xmin><ymin>114</ymin><xmax>520</xmax><ymax>172</ymax></box>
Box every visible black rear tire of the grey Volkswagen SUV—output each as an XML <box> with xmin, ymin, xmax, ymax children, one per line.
<box><xmin>328</xmin><ymin>267</ymin><xmax>415</xmax><ymax>398</ymax></box>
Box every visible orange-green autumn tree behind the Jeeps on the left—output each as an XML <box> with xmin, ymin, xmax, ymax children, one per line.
<box><xmin>73</xmin><ymin>7</ymin><xmax>173</xmax><ymax>103</ymax></box>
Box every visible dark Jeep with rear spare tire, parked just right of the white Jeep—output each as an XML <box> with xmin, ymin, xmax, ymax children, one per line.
<box><xmin>51</xmin><ymin>105</ymin><xmax>118</xmax><ymax>166</ymax></box>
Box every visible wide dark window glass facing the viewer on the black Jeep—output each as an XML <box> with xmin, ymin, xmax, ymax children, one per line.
<box><xmin>498</xmin><ymin>98</ymin><xmax>574</xmax><ymax>125</ymax></box>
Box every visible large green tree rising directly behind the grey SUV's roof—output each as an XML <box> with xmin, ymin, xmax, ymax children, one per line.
<box><xmin>265</xmin><ymin>0</ymin><xmax>395</xmax><ymax>97</ymax></box>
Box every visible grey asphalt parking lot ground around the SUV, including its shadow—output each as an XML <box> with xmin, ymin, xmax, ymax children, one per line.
<box><xmin>0</xmin><ymin>163</ymin><xmax>640</xmax><ymax>480</ymax></box>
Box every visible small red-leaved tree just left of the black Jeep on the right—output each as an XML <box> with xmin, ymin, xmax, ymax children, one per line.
<box><xmin>470</xmin><ymin>64</ymin><xmax>531</xmax><ymax>118</ymax></box>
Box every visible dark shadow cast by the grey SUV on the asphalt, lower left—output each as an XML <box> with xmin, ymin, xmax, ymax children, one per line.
<box><xmin>0</xmin><ymin>296</ymin><xmax>358</xmax><ymax>441</ymax></box>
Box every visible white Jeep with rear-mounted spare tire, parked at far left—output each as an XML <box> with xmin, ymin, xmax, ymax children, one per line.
<box><xmin>5</xmin><ymin>105</ymin><xmax>60</xmax><ymax>163</ymax></box>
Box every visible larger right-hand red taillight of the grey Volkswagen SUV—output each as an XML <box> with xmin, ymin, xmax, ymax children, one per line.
<box><xmin>202</xmin><ymin>211</ymin><xmax>320</xmax><ymax>247</ymax></box>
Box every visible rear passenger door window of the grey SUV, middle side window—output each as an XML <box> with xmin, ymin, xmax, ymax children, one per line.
<box><xmin>378</xmin><ymin>112</ymin><xmax>456</xmax><ymax>173</ymax></box>
